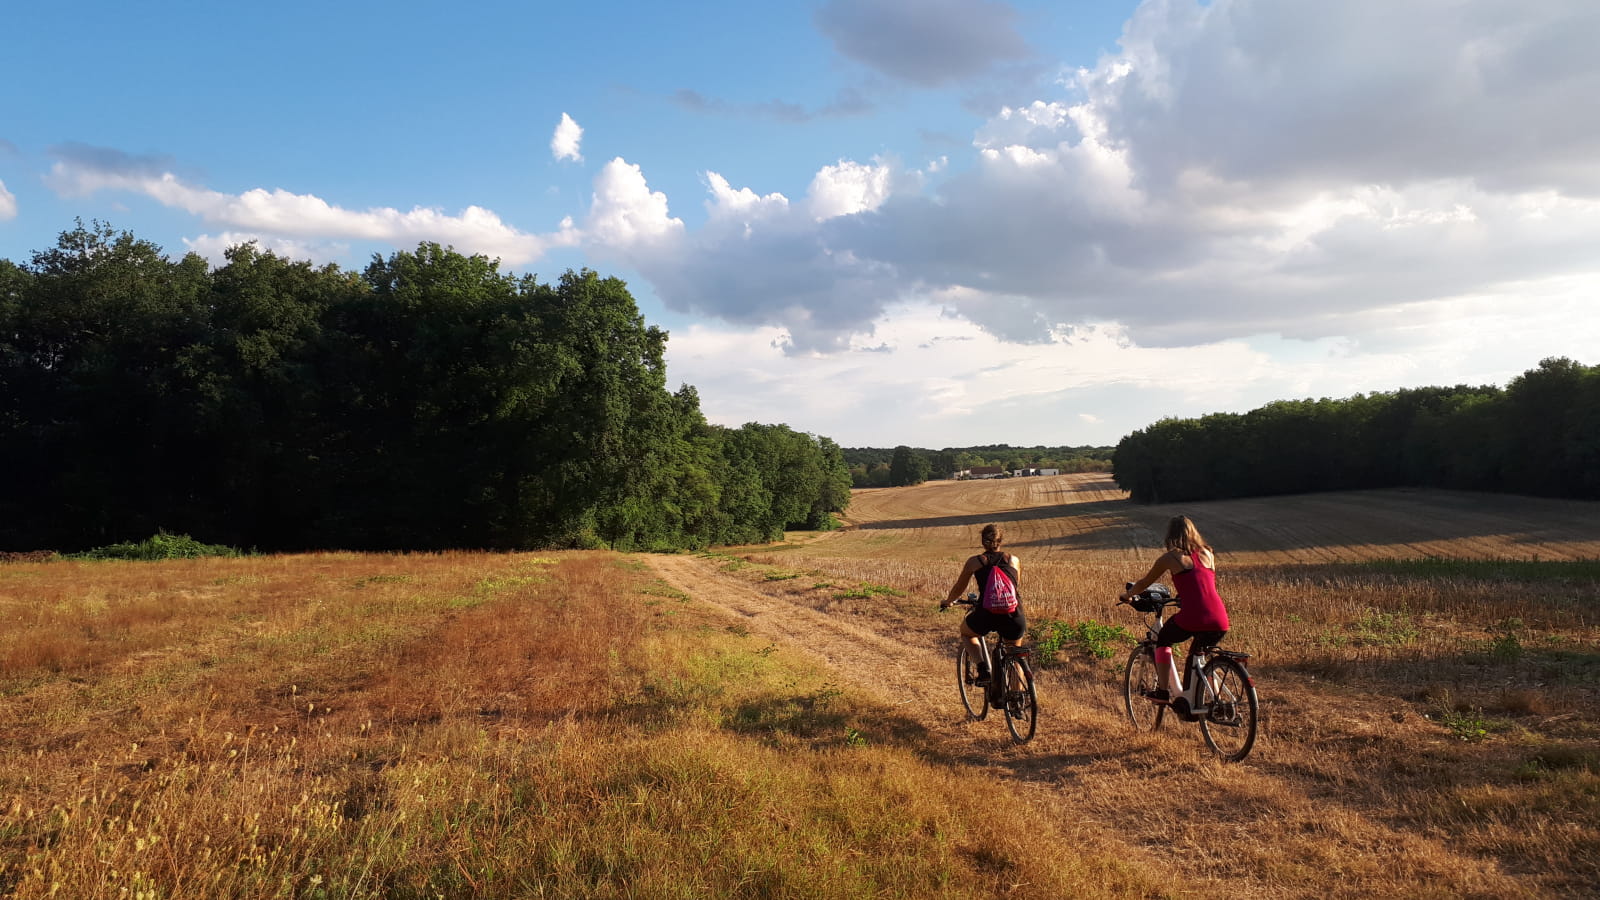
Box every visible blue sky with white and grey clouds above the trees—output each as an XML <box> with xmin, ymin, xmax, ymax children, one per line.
<box><xmin>0</xmin><ymin>0</ymin><xmax>1600</xmax><ymax>447</ymax></box>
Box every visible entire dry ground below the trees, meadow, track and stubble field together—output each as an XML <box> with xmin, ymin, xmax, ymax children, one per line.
<box><xmin>0</xmin><ymin>476</ymin><xmax>1600</xmax><ymax>898</ymax></box>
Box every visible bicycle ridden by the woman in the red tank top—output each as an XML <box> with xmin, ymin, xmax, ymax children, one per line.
<box><xmin>1122</xmin><ymin>581</ymin><xmax>1261</xmax><ymax>762</ymax></box>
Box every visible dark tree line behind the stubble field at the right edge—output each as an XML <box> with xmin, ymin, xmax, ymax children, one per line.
<box><xmin>1112</xmin><ymin>359</ymin><xmax>1600</xmax><ymax>503</ymax></box>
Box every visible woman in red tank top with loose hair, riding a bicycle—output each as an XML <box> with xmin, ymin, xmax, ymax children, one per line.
<box><xmin>1118</xmin><ymin>516</ymin><xmax>1227</xmax><ymax>713</ymax></box>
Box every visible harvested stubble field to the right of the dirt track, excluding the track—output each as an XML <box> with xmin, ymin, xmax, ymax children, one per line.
<box><xmin>726</xmin><ymin>476</ymin><xmax>1600</xmax><ymax>895</ymax></box>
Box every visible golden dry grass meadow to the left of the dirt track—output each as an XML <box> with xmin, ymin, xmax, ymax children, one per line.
<box><xmin>0</xmin><ymin>554</ymin><xmax>1160</xmax><ymax>898</ymax></box>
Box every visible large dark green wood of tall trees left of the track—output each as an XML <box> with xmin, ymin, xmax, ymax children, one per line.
<box><xmin>0</xmin><ymin>223</ymin><xmax>850</xmax><ymax>551</ymax></box>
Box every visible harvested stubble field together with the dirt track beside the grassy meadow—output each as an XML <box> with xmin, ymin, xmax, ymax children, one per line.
<box><xmin>678</xmin><ymin>476</ymin><xmax>1600</xmax><ymax>897</ymax></box>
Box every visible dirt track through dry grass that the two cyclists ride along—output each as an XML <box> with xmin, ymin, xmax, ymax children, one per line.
<box><xmin>645</xmin><ymin>509</ymin><xmax>1539</xmax><ymax>897</ymax></box>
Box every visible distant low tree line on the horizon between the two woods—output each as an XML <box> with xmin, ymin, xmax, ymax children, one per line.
<box><xmin>845</xmin><ymin>444</ymin><xmax>1112</xmax><ymax>487</ymax></box>
